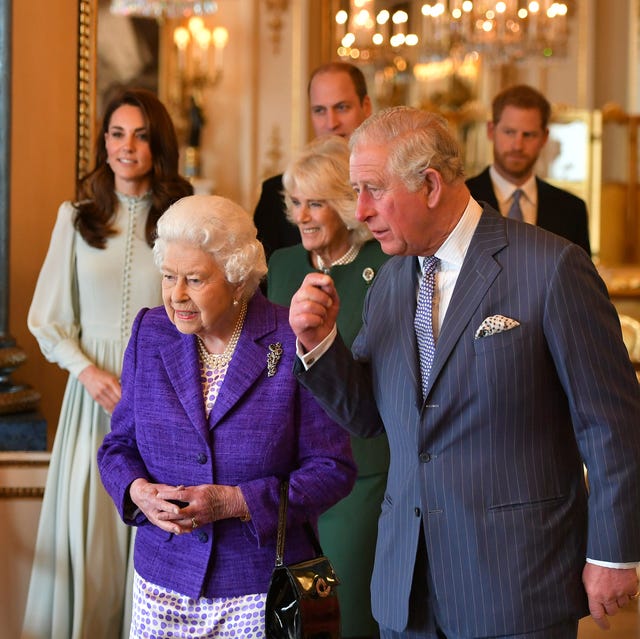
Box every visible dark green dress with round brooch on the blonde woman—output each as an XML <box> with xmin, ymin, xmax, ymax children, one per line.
<box><xmin>267</xmin><ymin>240</ymin><xmax>389</xmax><ymax>637</ymax></box>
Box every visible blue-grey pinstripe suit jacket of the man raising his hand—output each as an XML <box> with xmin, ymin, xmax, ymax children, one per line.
<box><xmin>296</xmin><ymin>206</ymin><xmax>640</xmax><ymax>637</ymax></box>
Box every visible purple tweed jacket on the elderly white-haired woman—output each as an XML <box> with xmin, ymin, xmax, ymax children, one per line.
<box><xmin>98</xmin><ymin>292</ymin><xmax>356</xmax><ymax>598</ymax></box>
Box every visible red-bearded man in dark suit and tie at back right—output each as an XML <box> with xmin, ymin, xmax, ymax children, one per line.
<box><xmin>467</xmin><ymin>85</ymin><xmax>591</xmax><ymax>255</ymax></box>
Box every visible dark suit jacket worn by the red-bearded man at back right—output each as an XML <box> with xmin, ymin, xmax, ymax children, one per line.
<box><xmin>467</xmin><ymin>167</ymin><xmax>591</xmax><ymax>255</ymax></box>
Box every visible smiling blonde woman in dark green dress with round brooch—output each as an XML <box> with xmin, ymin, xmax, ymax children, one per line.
<box><xmin>267</xmin><ymin>136</ymin><xmax>389</xmax><ymax>638</ymax></box>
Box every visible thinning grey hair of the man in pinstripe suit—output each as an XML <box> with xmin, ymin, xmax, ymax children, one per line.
<box><xmin>350</xmin><ymin>106</ymin><xmax>464</xmax><ymax>192</ymax></box>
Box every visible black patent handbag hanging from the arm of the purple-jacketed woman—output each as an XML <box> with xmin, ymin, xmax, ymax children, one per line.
<box><xmin>265</xmin><ymin>481</ymin><xmax>340</xmax><ymax>639</ymax></box>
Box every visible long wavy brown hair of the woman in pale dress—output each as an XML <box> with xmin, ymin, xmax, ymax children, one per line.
<box><xmin>74</xmin><ymin>88</ymin><xmax>193</xmax><ymax>249</ymax></box>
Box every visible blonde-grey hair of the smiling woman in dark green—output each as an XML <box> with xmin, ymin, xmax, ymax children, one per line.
<box><xmin>282</xmin><ymin>135</ymin><xmax>373</xmax><ymax>246</ymax></box>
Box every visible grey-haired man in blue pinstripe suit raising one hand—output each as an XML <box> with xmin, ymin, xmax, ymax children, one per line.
<box><xmin>290</xmin><ymin>107</ymin><xmax>640</xmax><ymax>639</ymax></box>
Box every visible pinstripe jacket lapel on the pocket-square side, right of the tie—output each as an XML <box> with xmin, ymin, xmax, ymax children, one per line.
<box><xmin>427</xmin><ymin>208</ymin><xmax>507</xmax><ymax>394</ymax></box>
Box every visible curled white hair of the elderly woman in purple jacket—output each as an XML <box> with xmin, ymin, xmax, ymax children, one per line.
<box><xmin>153</xmin><ymin>195</ymin><xmax>267</xmax><ymax>299</ymax></box>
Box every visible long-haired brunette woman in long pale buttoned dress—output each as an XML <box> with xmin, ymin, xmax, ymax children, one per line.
<box><xmin>22</xmin><ymin>90</ymin><xmax>192</xmax><ymax>639</ymax></box>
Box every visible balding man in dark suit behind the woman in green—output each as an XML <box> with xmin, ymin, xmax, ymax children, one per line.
<box><xmin>253</xmin><ymin>62</ymin><xmax>371</xmax><ymax>260</ymax></box>
